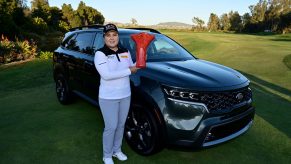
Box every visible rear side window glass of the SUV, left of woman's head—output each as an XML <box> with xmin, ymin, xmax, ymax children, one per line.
<box><xmin>67</xmin><ymin>32</ymin><xmax>95</xmax><ymax>54</ymax></box>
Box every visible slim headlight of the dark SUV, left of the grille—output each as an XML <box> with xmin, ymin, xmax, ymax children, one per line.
<box><xmin>162</xmin><ymin>85</ymin><xmax>200</xmax><ymax>101</ymax></box>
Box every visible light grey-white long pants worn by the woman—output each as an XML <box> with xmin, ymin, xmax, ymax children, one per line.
<box><xmin>99</xmin><ymin>96</ymin><xmax>130</xmax><ymax>158</ymax></box>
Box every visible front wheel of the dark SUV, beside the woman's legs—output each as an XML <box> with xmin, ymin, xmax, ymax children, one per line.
<box><xmin>125</xmin><ymin>103</ymin><xmax>164</xmax><ymax>156</ymax></box>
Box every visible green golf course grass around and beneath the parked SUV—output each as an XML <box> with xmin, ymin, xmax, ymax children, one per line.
<box><xmin>0</xmin><ymin>31</ymin><xmax>291</xmax><ymax>164</ymax></box>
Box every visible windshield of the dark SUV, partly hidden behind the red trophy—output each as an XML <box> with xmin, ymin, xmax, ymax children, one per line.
<box><xmin>119</xmin><ymin>35</ymin><xmax>194</xmax><ymax>61</ymax></box>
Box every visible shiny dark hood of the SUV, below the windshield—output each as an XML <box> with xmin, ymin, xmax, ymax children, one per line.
<box><xmin>141</xmin><ymin>59</ymin><xmax>249</xmax><ymax>90</ymax></box>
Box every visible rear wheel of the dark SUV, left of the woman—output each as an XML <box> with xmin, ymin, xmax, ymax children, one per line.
<box><xmin>55</xmin><ymin>74</ymin><xmax>73</xmax><ymax>105</ymax></box>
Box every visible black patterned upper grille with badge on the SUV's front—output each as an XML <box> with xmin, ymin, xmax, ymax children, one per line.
<box><xmin>200</xmin><ymin>88</ymin><xmax>252</xmax><ymax>113</ymax></box>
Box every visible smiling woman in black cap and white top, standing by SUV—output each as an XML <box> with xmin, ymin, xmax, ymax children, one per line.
<box><xmin>94</xmin><ymin>24</ymin><xmax>138</xmax><ymax>164</ymax></box>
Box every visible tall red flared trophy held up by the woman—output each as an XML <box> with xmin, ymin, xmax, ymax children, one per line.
<box><xmin>131</xmin><ymin>32</ymin><xmax>155</xmax><ymax>68</ymax></box>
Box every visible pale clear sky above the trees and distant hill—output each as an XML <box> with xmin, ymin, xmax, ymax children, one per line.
<box><xmin>27</xmin><ymin>0</ymin><xmax>259</xmax><ymax>25</ymax></box>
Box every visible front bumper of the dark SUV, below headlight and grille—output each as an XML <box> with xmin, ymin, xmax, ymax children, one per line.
<box><xmin>165</xmin><ymin>98</ymin><xmax>255</xmax><ymax>147</ymax></box>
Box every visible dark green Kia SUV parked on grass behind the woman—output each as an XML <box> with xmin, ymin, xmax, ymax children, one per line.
<box><xmin>53</xmin><ymin>25</ymin><xmax>255</xmax><ymax>155</ymax></box>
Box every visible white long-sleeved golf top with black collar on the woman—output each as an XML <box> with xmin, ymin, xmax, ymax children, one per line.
<box><xmin>94</xmin><ymin>45</ymin><xmax>133</xmax><ymax>99</ymax></box>
